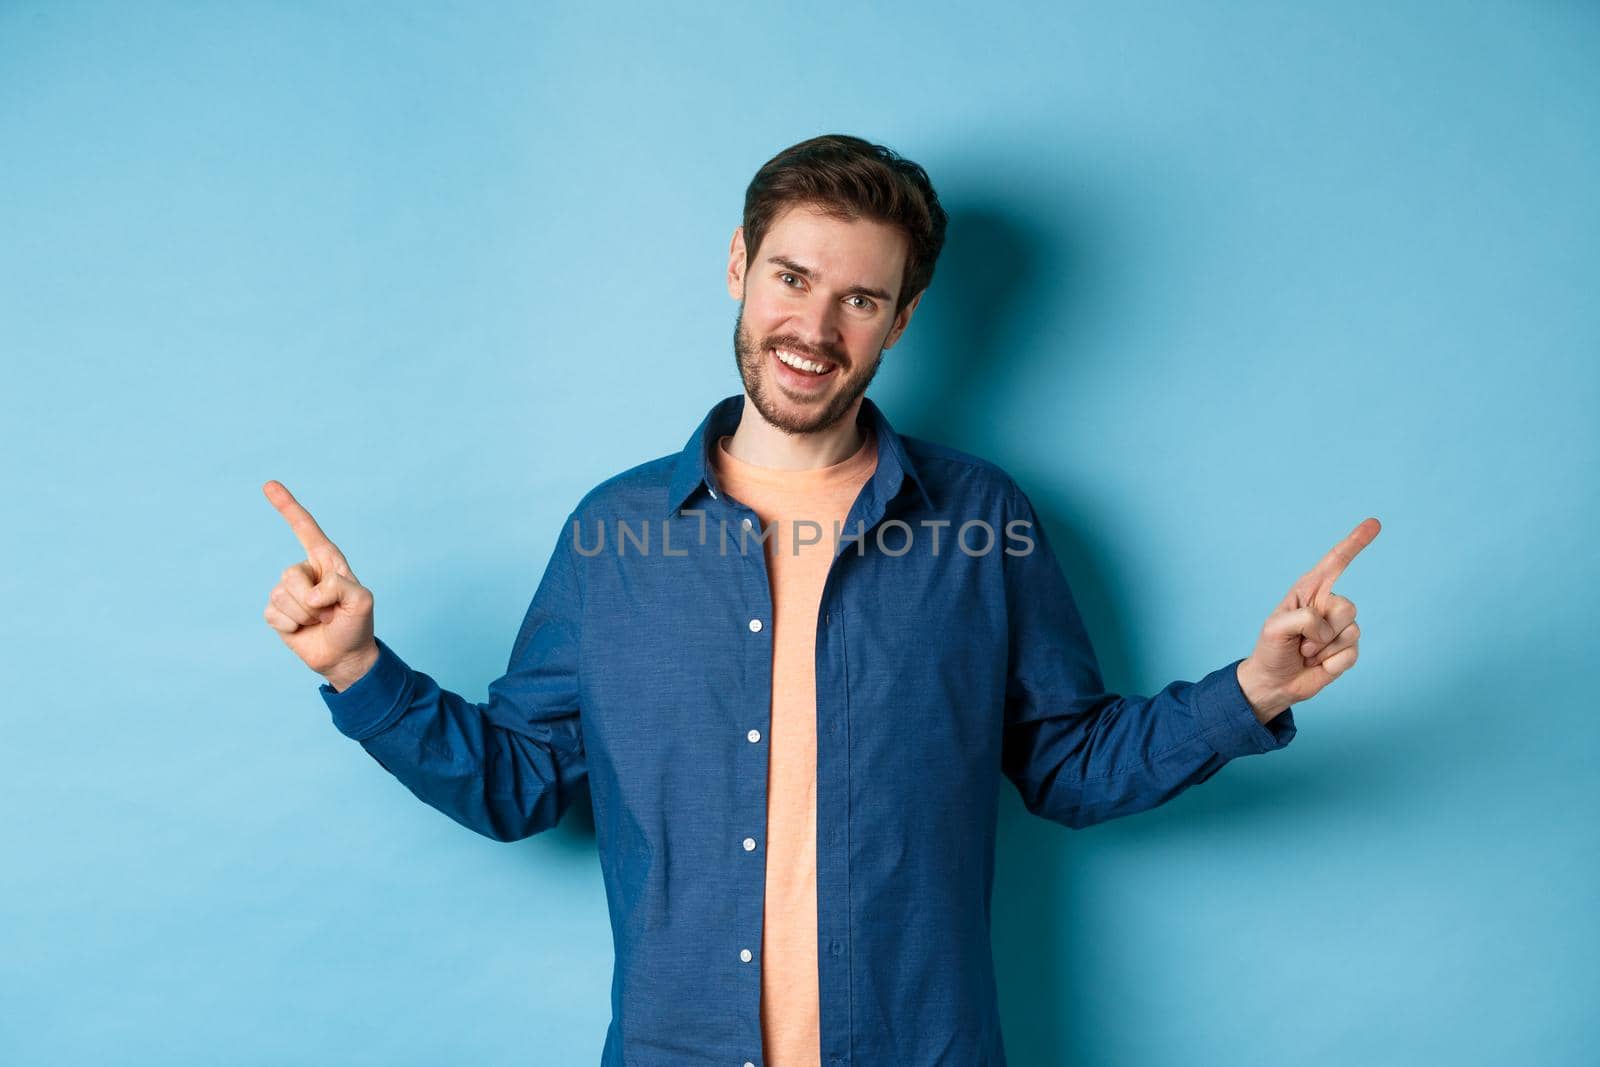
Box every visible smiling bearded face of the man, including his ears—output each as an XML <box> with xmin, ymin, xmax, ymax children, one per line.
<box><xmin>728</xmin><ymin>205</ymin><xmax>922</xmax><ymax>434</ymax></box>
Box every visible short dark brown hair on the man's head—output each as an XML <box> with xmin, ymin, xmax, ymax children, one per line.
<box><xmin>744</xmin><ymin>133</ymin><xmax>946</xmax><ymax>315</ymax></box>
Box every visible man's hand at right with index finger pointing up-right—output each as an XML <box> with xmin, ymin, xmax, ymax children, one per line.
<box><xmin>1238</xmin><ymin>518</ymin><xmax>1382</xmax><ymax>723</ymax></box>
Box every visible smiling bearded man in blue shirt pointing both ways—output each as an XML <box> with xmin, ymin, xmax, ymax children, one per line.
<box><xmin>264</xmin><ymin>136</ymin><xmax>1378</xmax><ymax>1067</ymax></box>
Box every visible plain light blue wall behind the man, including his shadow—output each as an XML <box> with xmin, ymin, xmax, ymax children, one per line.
<box><xmin>0</xmin><ymin>2</ymin><xmax>1600</xmax><ymax>1067</ymax></box>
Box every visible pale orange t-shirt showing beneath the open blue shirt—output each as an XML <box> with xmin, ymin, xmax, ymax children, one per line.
<box><xmin>712</xmin><ymin>430</ymin><xmax>878</xmax><ymax>1067</ymax></box>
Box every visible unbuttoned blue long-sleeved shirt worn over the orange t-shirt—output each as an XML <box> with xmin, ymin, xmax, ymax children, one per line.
<box><xmin>322</xmin><ymin>394</ymin><xmax>1294</xmax><ymax>1067</ymax></box>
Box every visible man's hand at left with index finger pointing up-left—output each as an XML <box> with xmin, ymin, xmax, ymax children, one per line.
<box><xmin>261</xmin><ymin>482</ymin><xmax>378</xmax><ymax>691</ymax></box>
